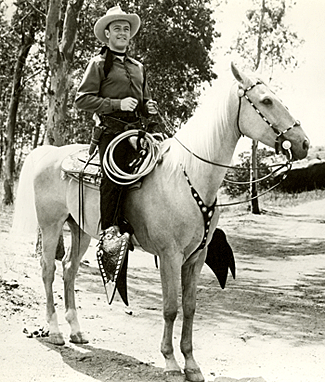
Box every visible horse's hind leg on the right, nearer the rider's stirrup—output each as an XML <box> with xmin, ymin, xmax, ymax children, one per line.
<box><xmin>62</xmin><ymin>217</ymin><xmax>90</xmax><ymax>344</ymax></box>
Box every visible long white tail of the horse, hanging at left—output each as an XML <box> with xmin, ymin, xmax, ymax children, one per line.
<box><xmin>10</xmin><ymin>149</ymin><xmax>38</xmax><ymax>236</ymax></box>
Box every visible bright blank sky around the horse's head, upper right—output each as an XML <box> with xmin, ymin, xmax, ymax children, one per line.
<box><xmin>205</xmin><ymin>0</ymin><xmax>325</xmax><ymax>149</ymax></box>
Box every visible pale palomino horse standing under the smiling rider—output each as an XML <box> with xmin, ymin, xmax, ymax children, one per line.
<box><xmin>15</xmin><ymin>65</ymin><xmax>309</xmax><ymax>381</ymax></box>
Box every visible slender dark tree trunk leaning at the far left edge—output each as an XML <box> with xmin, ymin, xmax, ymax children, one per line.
<box><xmin>3</xmin><ymin>36</ymin><xmax>34</xmax><ymax>205</ymax></box>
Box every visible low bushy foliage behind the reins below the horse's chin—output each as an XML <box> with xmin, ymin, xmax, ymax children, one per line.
<box><xmin>222</xmin><ymin>148</ymin><xmax>274</xmax><ymax>198</ymax></box>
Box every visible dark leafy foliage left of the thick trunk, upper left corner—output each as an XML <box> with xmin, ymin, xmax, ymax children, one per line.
<box><xmin>0</xmin><ymin>0</ymin><xmax>45</xmax><ymax>172</ymax></box>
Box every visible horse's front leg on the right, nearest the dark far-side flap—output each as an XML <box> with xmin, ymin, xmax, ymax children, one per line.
<box><xmin>181</xmin><ymin>252</ymin><xmax>205</xmax><ymax>382</ymax></box>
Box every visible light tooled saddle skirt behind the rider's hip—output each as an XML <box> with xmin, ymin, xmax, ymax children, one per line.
<box><xmin>61</xmin><ymin>147</ymin><xmax>102</xmax><ymax>190</ymax></box>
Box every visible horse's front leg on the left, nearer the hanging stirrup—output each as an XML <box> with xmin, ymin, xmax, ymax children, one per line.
<box><xmin>160</xmin><ymin>251</ymin><xmax>182</xmax><ymax>375</ymax></box>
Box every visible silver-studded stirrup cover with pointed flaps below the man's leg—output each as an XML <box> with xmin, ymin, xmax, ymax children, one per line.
<box><xmin>97</xmin><ymin>226</ymin><xmax>130</xmax><ymax>306</ymax></box>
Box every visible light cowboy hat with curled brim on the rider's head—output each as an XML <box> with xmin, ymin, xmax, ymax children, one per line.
<box><xmin>94</xmin><ymin>5</ymin><xmax>141</xmax><ymax>44</ymax></box>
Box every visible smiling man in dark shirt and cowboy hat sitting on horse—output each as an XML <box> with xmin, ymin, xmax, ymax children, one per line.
<box><xmin>75</xmin><ymin>6</ymin><xmax>157</xmax><ymax>303</ymax></box>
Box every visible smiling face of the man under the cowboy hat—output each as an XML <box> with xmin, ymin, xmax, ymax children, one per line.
<box><xmin>105</xmin><ymin>20</ymin><xmax>131</xmax><ymax>52</ymax></box>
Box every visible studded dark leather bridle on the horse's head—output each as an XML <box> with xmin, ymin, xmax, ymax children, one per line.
<box><xmin>237</xmin><ymin>80</ymin><xmax>300</xmax><ymax>160</ymax></box>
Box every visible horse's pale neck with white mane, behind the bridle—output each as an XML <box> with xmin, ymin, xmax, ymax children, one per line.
<box><xmin>166</xmin><ymin>86</ymin><xmax>239</xmax><ymax>204</ymax></box>
